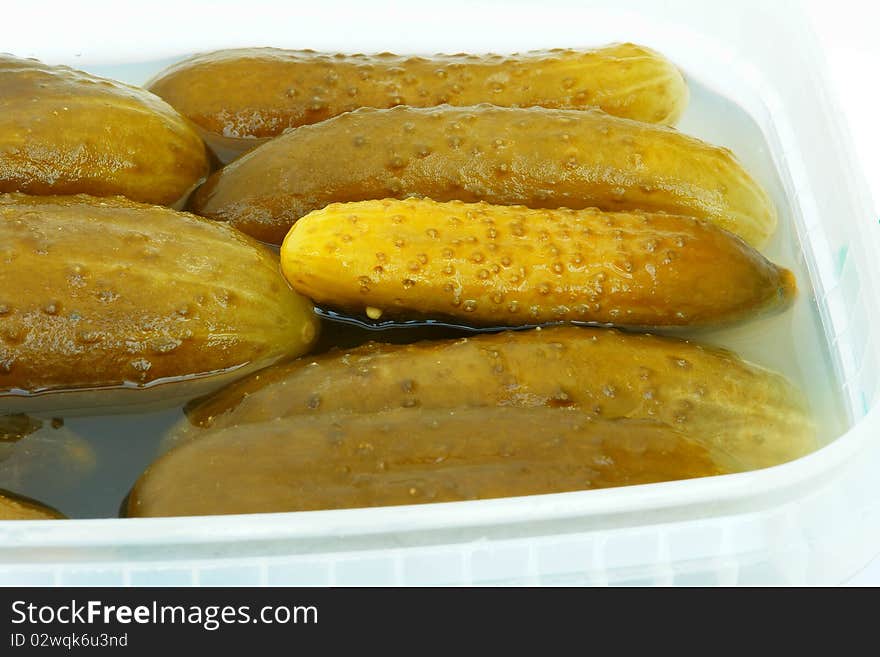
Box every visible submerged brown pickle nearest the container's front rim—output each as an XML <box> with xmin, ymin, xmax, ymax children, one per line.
<box><xmin>126</xmin><ymin>408</ymin><xmax>726</xmax><ymax>516</ymax></box>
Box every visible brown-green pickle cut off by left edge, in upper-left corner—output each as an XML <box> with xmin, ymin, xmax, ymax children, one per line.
<box><xmin>0</xmin><ymin>55</ymin><xmax>208</xmax><ymax>205</ymax></box>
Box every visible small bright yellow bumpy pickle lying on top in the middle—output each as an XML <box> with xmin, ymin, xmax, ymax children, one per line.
<box><xmin>281</xmin><ymin>199</ymin><xmax>796</xmax><ymax>326</ymax></box>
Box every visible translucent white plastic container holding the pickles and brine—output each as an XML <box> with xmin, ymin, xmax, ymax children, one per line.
<box><xmin>0</xmin><ymin>0</ymin><xmax>880</xmax><ymax>585</ymax></box>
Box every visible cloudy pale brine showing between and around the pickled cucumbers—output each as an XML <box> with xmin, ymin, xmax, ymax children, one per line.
<box><xmin>0</xmin><ymin>61</ymin><xmax>848</xmax><ymax>518</ymax></box>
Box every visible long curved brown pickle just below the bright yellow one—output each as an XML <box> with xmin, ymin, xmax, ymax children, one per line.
<box><xmin>182</xmin><ymin>326</ymin><xmax>815</xmax><ymax>469</ymax></box>
